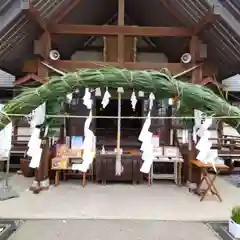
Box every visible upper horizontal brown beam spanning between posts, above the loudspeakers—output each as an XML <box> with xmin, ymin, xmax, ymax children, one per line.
<box><xmin>50</xmin><ymin>24</ymin><xmax>193</xmax><ymax>37</ymax></box>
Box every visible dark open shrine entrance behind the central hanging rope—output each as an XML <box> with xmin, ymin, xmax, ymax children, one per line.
<box><xmin>95</xmin><ymin>99</ymin><xmax>144</xmax><ymax>148</ymax></box>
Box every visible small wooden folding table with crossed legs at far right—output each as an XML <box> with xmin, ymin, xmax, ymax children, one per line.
<box><xmin>191</xmin><ymin>160</ymin><xmax>228</xmax><ymax>202</ymax></box>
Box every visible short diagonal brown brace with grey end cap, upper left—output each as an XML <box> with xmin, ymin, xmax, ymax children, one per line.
<box><xmin>22</xmin><ymin>0</ymin><xmax>49</xmax><ymax>32</ymax></box>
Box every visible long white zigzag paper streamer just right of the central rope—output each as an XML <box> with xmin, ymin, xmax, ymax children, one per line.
<box><xmin>138</xmin><ymin>93</ymin><xmax>155</xmax><ymax>173</ymax></box>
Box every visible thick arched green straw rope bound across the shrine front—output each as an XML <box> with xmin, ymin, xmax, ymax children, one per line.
<box><xmin>0</xmin><ymin>67</ymin><xmax>240</xmax><ymax>132</ymax></box>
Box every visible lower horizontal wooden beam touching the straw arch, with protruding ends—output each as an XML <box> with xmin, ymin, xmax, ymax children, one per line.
<box><xmin>23</xmin><ymin>60</ymin><xmax>217</xmax><ymax>76</ymax></box>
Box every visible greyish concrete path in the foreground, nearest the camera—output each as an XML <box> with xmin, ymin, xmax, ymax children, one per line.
<box><xmin>10</xmin><ymin>220</ymin><xmax>219</xmax><ymax>240</ymax></box>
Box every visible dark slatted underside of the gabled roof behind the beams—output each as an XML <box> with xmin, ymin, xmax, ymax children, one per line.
<box><xmin>0</xmin><ymin>0</ymin><xmax>240</xmax><ymax>79</ymax></box>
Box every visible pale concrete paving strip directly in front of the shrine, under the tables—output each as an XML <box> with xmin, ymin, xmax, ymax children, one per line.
<box><xmin>0</xmin><ymin>175</ymin><xmax>240</xmax><ymax>221</ymax></box>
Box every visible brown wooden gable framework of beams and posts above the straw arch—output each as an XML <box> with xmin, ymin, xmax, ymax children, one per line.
<box><xmin>15</xmin><ymin>0</ymin><xmax>222</xmax><ymax>142</ymax></box>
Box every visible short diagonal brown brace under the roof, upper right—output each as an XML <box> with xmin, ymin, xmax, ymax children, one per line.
<box><xmin>193</xmin><ymin>11</ymin><xmax>219</xmax><ymax>36</ymax></box>
